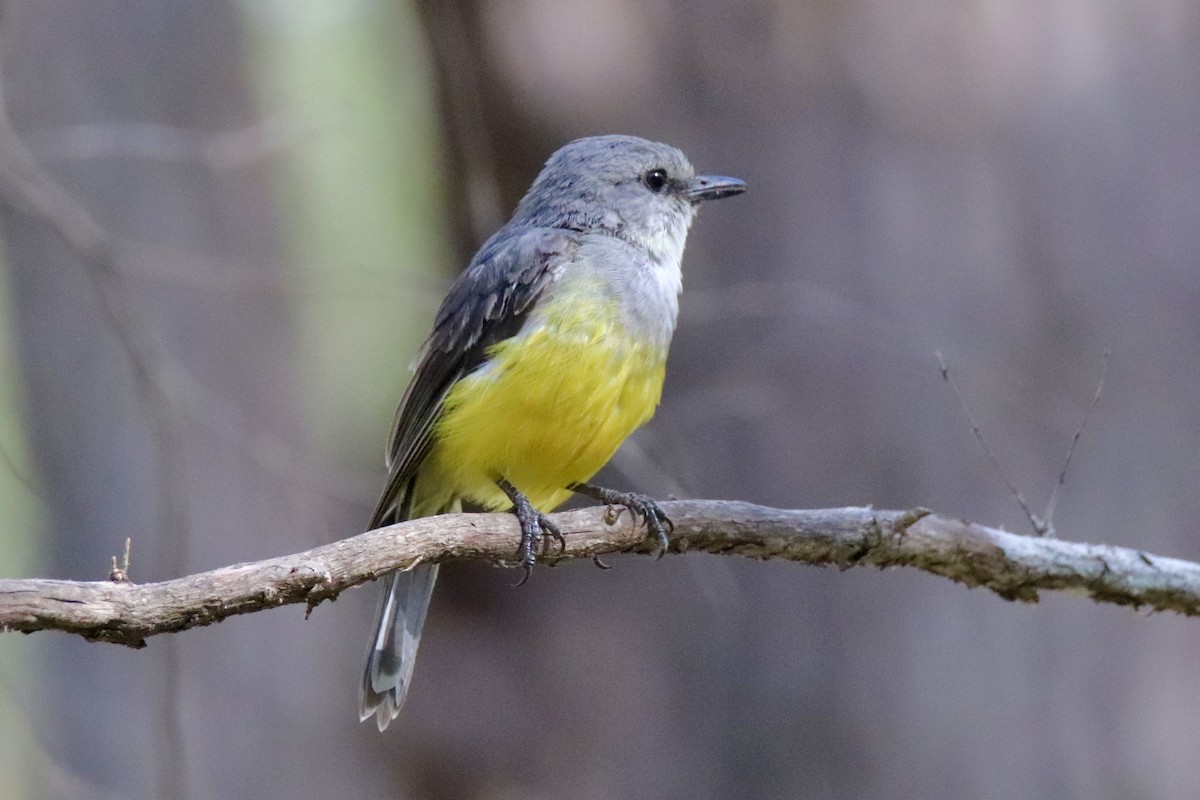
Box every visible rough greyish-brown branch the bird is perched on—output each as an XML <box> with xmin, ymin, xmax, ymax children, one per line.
<box><xmin>0</xmin><ymin>500</ymin><xmax>1200</xmax><ymax>648</ymax></box>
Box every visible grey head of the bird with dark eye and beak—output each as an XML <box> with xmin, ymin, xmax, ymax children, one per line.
<box><xmin>512</xmin><ymin>136</ymin><xmax>746</xmax><ymax>257</ymax></box>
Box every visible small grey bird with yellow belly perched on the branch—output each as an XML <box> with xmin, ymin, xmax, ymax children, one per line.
<box><xmin>359</xmin><ymin>136</ymin><xmax>746</xmax><ymax>732</ymax></box>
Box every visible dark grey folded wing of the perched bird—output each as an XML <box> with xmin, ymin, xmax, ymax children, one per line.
<box><xmin>367</xmin><ymin>228</ymin><xmax>578</xmax><ymax>530</ymax></box>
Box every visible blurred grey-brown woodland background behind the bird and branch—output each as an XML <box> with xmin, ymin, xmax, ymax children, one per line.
<box><xmin>0</xmin><ymin>0</ymin><xmax>1200</xmax><ymax>800</ymax></box>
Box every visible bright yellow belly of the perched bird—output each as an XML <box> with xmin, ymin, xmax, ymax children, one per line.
<box><xmin>418</xmin><ymin>293</ymin><xmax>665</xmax><ymax>511</ymax></box>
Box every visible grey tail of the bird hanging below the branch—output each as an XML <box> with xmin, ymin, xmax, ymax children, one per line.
<box><xmin>359</xmin><ymin>564</ymin><xmax>438</xmax><ymax>730</ymax></box>
